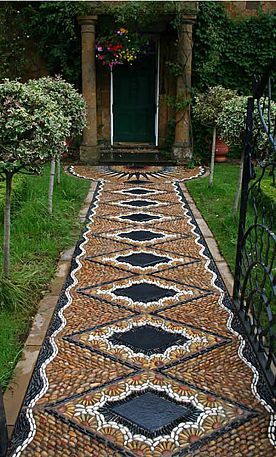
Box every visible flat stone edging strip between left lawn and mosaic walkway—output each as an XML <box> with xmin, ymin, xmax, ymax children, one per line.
<box><xmin>4</xmin><ymin>181</ymin><xmax>97</xmax><ymax>436</ymax></box>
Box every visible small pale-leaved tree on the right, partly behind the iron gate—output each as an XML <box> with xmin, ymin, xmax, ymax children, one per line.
<box><xmin>217</xmin><ymin>96</ymin><xmax>276</xmax><ymax>211</ymax></box>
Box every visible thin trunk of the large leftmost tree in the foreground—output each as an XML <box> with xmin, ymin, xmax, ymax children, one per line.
<box><xmin>3</xmin><ymin>173</ymin><xmax>12</xmax><ymax>278</ymax></box>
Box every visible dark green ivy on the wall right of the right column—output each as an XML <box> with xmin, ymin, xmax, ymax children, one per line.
<box><xmin>193</xmin><ymin>2</ymin><xmax>276</xmax><ymax>95</ymax></box>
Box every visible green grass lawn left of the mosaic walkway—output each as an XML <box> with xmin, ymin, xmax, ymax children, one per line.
<box><xmin>0</xmin><ymin>166</ymin><xmax>89</xmax><ymax>387</ymax></box>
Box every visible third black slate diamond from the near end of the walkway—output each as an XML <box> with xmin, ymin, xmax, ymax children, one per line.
<box><xmin>113</xmin><ymin>282</ymin><xmax>177</xmax><ymax>303</ymax></box>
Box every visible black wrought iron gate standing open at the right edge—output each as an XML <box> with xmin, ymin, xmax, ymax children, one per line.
<box><xmin>233</xmin><ymin>62</ymin><xmax>276</xmax><ymax>394</ymax></box>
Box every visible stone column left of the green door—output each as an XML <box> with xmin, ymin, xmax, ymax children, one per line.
<box><xmin>78</xmin><ymin>16</ymin><xmax>98</xmax><ymax>164</ymax></box>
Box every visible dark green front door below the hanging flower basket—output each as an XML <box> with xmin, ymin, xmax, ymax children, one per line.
<box><xmin>113</xmin><ymin>55</ymin><xmax>156</xmax><ymax>143</ymax></box>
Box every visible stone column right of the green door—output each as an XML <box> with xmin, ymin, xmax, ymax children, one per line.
<box><xmin>173</xmin><ymin>17</ymin><xmax>195</xmax><ymax>163</ymax></box>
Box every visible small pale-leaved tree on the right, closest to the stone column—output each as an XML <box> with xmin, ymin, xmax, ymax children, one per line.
<box><xmin>193</xmin><ymin>86</ymin><xmax>236</xmax><ymax>186</ymax></box>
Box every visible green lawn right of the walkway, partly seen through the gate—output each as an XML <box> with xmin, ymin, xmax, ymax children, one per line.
<box><xmin>186</xmin><ymin>163</ymin><xmax>276</xmax><ymax>320</ymax></box>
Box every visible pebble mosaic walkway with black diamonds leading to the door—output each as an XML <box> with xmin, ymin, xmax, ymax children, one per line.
<box><xmin>9</xmin><ymin>166</ymin><xmax>276</xmax><ymax>457</ymax></box>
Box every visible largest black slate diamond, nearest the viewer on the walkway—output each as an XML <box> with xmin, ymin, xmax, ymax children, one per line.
<box><xmin>100</xmin><ymin>389</ymin><xmax>201</xmax><ymax>438</ymax></box>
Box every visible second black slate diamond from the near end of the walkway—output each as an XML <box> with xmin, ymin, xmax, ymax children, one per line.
<box><xmin>109</xmin><ymin>324</ymin><xmax>188</xmax><ymax>355</ymax></box>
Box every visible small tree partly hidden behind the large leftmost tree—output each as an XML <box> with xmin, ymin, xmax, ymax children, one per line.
<box><xmin>28</xmin><ymin>76</ymin><xmax>86</xmax><ymax>214</ymax></box>
